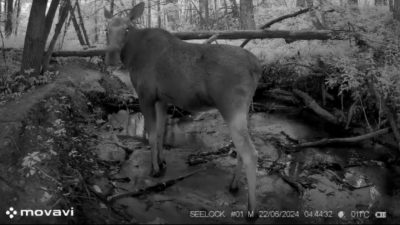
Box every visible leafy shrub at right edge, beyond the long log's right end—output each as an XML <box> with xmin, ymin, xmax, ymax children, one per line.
<box><xmin>318</xmin><ymin>5</ymin><xmax>400</xmax><ymax>126</ymax></box>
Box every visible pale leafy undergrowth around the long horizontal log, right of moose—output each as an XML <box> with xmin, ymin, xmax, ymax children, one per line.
<box><xmin>248</xmin><ymin>2</ymin><xmax>400</xmax><ymax>129</ymax></box>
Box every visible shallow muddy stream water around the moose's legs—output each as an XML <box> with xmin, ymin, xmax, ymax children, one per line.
<box><xmin>95</xmin><ymin>111</ymin><xmax>400</xmax><ymax>223</ymax></box>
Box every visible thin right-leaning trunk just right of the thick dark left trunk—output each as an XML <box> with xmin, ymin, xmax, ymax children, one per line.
<box><xmin>43</xmin><ymin>0</ymin><xmax>69</xmax><ymax>71</ymax></box>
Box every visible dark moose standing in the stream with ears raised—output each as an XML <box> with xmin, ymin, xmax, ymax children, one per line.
<box><xmin>104</xmin><ymin>2</ymin><xmax>262</xmax><ymax>216</ymax></box>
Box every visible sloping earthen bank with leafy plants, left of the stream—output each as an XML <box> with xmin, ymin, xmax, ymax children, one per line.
<box><xmin>0</xmin><ymin>64</ymin><xmax>125</xmax><ymax>223</ymax></box>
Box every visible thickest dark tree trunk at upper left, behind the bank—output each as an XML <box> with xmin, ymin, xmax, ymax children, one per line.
<box><xmin>21</xmin><ymin>0</ymin><xmax>47</xmax><ymax>75</ymax></box>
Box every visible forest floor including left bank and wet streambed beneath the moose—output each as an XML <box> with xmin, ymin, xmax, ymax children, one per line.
<box><xmin>0</xmin><ymin>62</ymin><xmax>400</xmax><ymax>224</ymax></box>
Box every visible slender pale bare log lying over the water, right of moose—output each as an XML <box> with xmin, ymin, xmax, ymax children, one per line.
<box><xmin>293</xmin><ymin>128</ymin><xmax>390</xmax><ymax>148</ymax></box>
